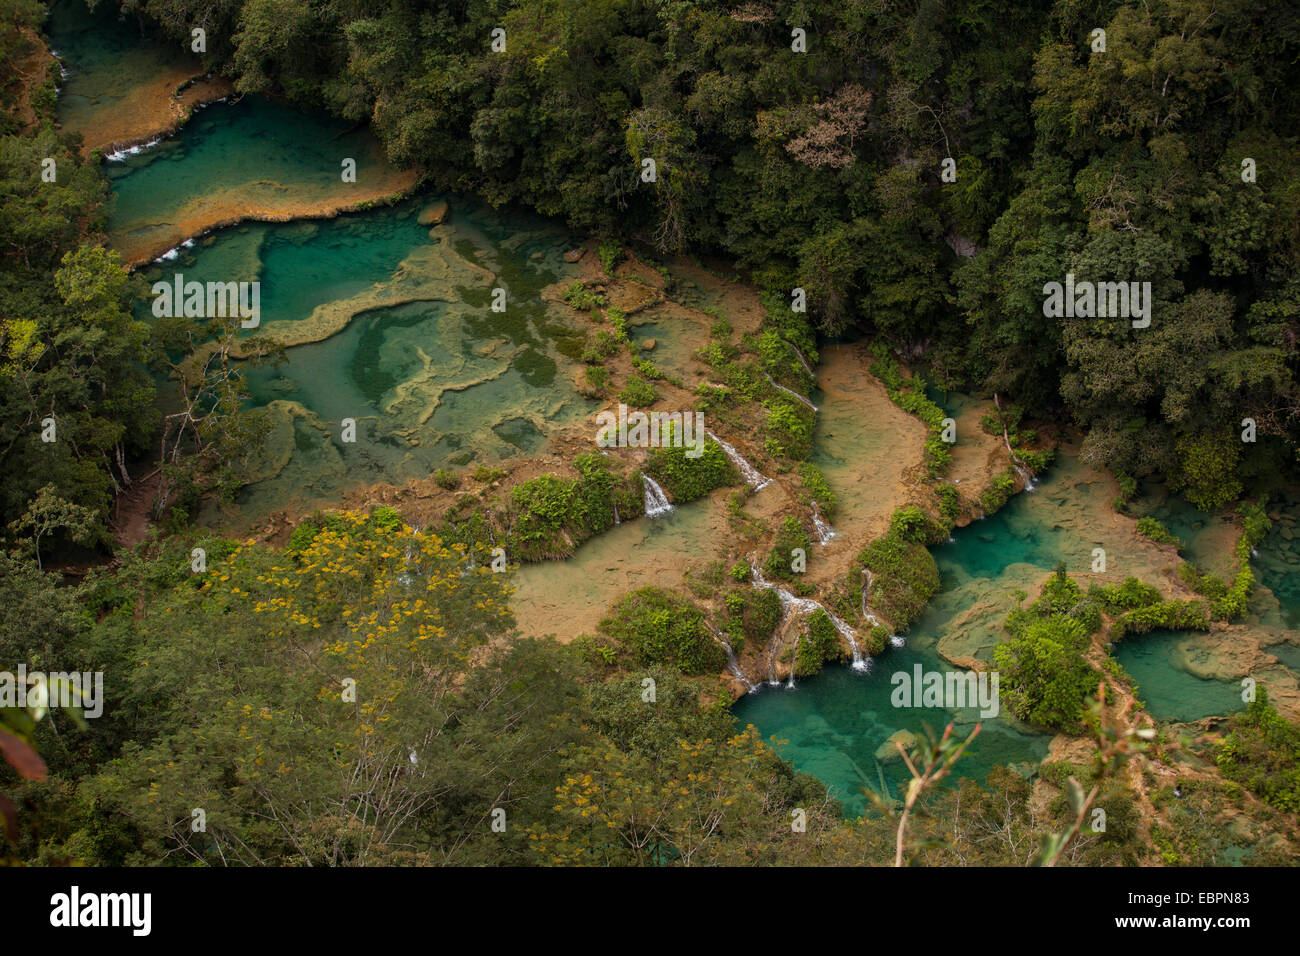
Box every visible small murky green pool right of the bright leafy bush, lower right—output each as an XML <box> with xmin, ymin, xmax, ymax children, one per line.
<box><xmin>1114</xmin><ymin>631</ymin><xmax>1244</xmax><ymax>721</ymax></box>
